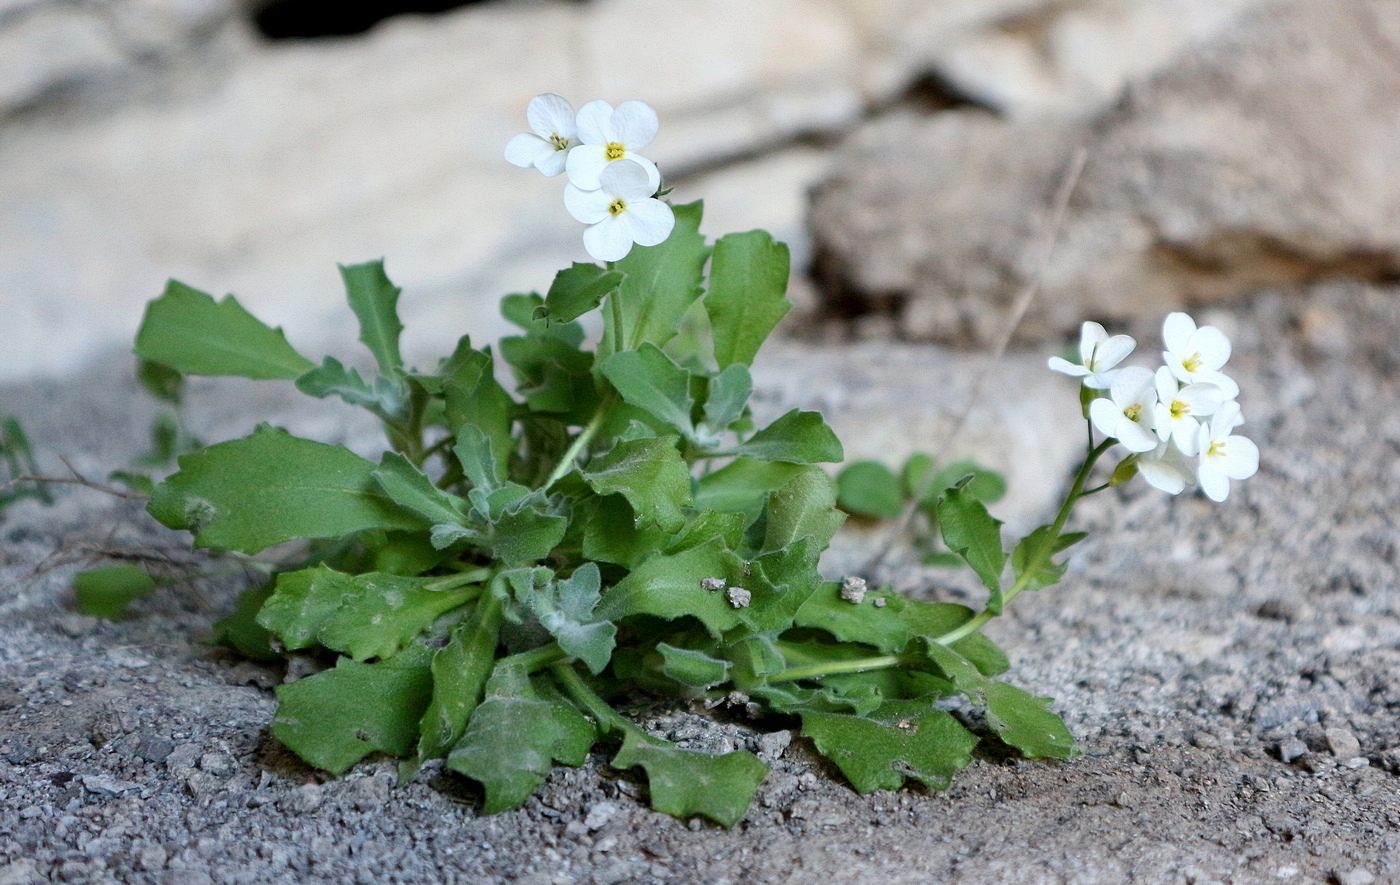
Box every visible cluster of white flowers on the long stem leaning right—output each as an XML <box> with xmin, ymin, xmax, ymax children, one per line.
<box><xmin>1050</xmin><ymin>312</ymin><xmax>1259</xmax><ymax>501</ymax></box>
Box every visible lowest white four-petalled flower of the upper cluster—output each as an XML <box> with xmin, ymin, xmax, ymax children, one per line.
<box><xmin>564</xmin><ymin>161</ymin><xmax>676</xmax><ymax>262</ymax></box>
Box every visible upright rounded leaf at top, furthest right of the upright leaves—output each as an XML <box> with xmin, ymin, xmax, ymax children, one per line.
<box><xmin>704</xmin><ymin>231</ymin><xmax>792</xmax><ymax>368</ymax></box>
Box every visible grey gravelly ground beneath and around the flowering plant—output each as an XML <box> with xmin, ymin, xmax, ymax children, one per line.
<box><xmin>0</xmin><ymin>283</ymin><xmax>1400</xmax><ymax>885</ymax></box>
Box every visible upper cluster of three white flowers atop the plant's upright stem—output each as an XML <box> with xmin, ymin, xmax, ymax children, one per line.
<box><xmin>505</xmin><ymin>92</ymin><xmax>676</xmax><ymax>262</ymax></box>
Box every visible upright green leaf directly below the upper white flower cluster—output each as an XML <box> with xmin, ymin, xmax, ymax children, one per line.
<box><xmin>610</xmin><ymin>202</ymin><xmax>710</xmax><ymax>353</ymax></box>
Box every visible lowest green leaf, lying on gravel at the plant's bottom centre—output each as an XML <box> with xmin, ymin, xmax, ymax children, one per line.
<box><xmin>612</xmin><ymin>732</ymin><xmax>769</xmax><ymax>826</ymax></box>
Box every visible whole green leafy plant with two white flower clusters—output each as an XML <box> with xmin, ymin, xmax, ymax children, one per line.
<box><xmin>106</xmin><ymin>94</ymin><xmax>1256</xmax><ymax>825</ymax></box>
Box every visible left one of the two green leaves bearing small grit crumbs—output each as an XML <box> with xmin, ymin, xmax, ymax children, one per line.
<box><xmin>596</xmin><ymin>538</ymin><xmax>743</xmax><ymax>636</ymax></box>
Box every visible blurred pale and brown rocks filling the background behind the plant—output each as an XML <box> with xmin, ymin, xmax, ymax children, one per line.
<box><xmin>0</xmin><ymin>0</ymin><xmax>1400</xmax><ymax>378</ymax></box>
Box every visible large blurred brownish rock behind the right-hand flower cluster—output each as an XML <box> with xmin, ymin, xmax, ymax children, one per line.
<box><xmin>812</xmin><ymin>0</ymin><xmax>1400</xmax><ymax>343</ymax></box>
